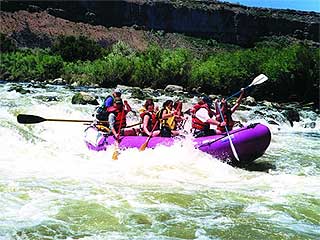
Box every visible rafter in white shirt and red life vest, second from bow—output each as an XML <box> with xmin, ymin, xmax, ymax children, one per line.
<box><xmin>190</xmin><ymin>97</ymin><xmax>226</xmax><ymax>137</ymax></box>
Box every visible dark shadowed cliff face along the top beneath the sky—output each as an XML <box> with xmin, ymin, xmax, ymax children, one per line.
<box><xmin>1</xmin><ymin>0</ymin><xmax>320</xmax><ymax>46</ymax></box>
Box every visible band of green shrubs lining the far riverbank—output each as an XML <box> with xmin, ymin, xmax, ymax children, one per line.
<box><xmin>0</xmin><ymin>38</ymin><xmax>320</xmax><ymax>101</ymax></box>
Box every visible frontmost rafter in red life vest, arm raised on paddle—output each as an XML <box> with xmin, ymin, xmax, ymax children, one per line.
<box><xmin>215</xmin><ymin>88</ymin><xmax>244</xmax><ymax>133</ymax></box>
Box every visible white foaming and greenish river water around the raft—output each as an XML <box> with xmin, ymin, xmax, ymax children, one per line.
<box><xmin>0</xmin><ymin>83</ymin><xmax>320</xmax><ymax>239</ymax></box>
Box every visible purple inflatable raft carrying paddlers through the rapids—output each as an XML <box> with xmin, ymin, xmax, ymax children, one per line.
<box><xmin>85</xmin><ymin>123</ymin><xmax>271</xmax><ymax>164</ymax></box>
